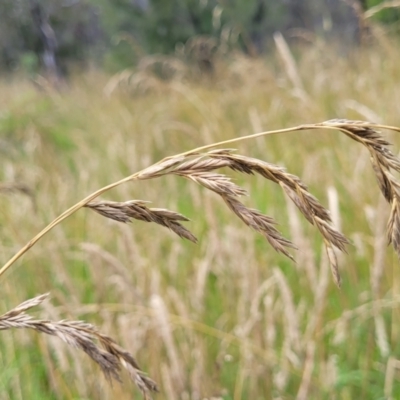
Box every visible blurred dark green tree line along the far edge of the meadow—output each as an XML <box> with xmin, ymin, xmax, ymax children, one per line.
<box><xmin>0</xmin><ymin>0</ymin><xmax>400</xmax><ymax>74</ymax></box>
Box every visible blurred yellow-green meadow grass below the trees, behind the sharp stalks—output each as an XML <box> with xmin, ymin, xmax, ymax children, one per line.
<box><xmin>0</xmin><ymin>39</ymin><xmax>400</xmax><ymax>400</ymax></box>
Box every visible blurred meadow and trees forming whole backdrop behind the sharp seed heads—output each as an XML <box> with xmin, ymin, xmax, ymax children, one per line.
<box><xmin>0</xmin><ymin>0</ymin><xmax>400</xmax><ymax>400</ymax></box>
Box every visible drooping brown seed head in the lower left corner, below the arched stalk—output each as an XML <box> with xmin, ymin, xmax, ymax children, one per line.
<box><xmin>0</xmin><ymin>293</ymin><xmax>158</xmax><ymax>399</ymax></box>
